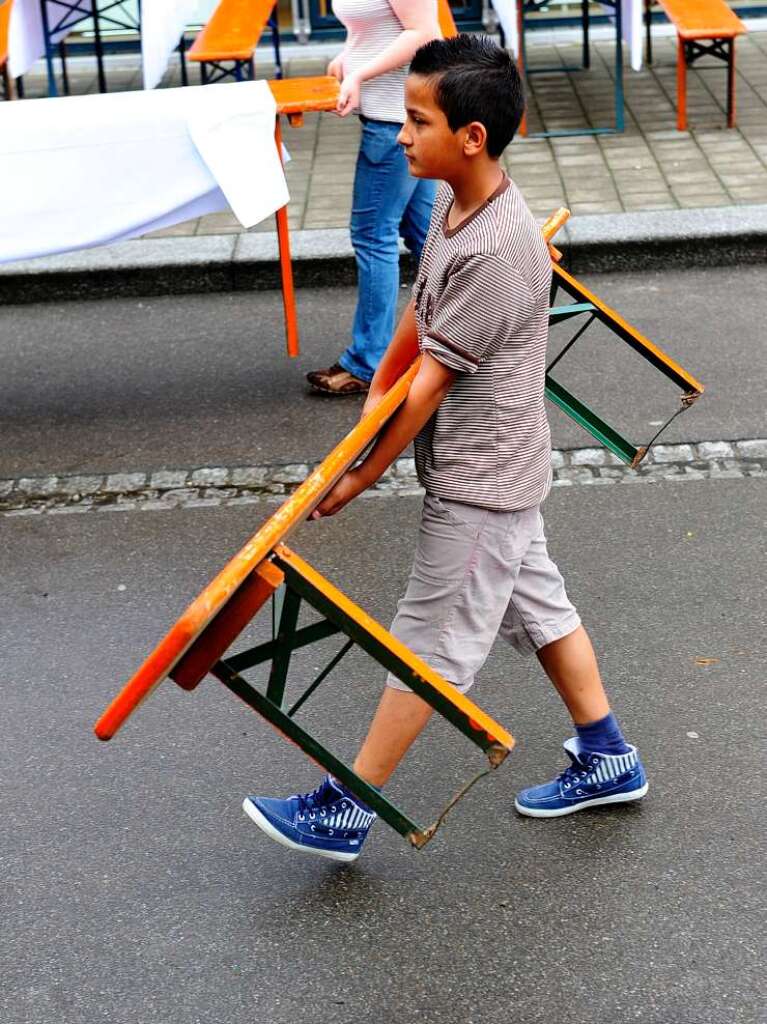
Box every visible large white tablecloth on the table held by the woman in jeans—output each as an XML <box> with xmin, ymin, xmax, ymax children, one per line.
<box><xmin>0</xmin><ymin>82</ymin><xmax>289</xmax><ymax>262</ymax></box>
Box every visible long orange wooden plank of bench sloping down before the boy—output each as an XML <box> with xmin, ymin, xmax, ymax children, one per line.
<box><xmin>94</xmin><ymin>359</ymin><xmax>420</xmax><ymax>739</ymax></box>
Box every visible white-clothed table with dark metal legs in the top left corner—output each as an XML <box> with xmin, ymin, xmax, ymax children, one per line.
<box><xmin>8</xmin><ymin>0</ymin><xmax>197</xmax><ymax>96</ymax></box>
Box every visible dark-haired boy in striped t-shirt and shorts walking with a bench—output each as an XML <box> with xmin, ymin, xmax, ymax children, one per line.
<box><xmin>243</xmin><ymin>35</ymin><xmax>647</xmax><ymax>861</ymax></box>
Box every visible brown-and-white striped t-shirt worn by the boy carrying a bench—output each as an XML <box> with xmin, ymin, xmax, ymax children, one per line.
<box><xmin>413</xmin><ymin>176</ymin><xmax>551</xmax><ymax>511</ymax></box>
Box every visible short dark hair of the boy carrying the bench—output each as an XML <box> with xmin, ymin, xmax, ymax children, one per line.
<box><xmin>410</xmin><ymin>33</ymin><xmax>524</xmax><ymax>159</ymax></box>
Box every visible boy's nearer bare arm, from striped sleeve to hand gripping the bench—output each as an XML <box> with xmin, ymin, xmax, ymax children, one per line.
<box><xmin>311</xmin><ymin>356</ymin><xmax>456</xmax><ymax>519</ymax></box>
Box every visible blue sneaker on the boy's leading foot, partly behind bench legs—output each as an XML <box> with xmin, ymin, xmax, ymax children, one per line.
<box><xmin>243</xmin><ymin>775</ymin><xmax>376</xmax><ymax>861</ymax></box>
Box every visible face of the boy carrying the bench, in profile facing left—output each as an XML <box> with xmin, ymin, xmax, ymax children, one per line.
<box><xmin>397</xmin><ymin>75</ymin><xmax>466</xmax><ymax>179</ymax></box>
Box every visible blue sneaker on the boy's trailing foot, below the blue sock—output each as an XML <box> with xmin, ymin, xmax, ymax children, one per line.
<box><xmin>514</xmin><ymin>737</ymin><xmax>647</xmax><ymax>818</ymax></box>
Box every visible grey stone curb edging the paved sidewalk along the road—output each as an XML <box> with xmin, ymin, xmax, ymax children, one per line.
<box><xmin>0</xmin><ymin>204</ymin><xmax>767</xmax><ymax>305</ymax></box>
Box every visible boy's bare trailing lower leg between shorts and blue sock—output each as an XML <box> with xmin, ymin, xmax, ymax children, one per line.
<box><xmin>538</xmin><ymin>626</ymin><xmax>610</xmax><ymax>725</ymax></box>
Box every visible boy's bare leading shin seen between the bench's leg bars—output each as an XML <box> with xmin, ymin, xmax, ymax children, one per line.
<box><xmin>354</xmin><ymin>686</ymin><xmax>432</xmax><ymax>786</ymax></box>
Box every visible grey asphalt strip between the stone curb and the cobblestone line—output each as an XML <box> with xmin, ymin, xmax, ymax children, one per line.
<box><xmin>0</xmin><ymin>260</ymin><xmax>767</xmax><ymax>478</ymax></box>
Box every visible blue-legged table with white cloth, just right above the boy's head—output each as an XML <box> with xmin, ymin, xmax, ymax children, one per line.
<box><xmin>492</xmin><ymin>0</ymin><xmax>644</xmax><ymax>137</ymax></box>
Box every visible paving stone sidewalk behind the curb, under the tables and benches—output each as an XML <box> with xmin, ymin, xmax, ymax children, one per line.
<box><xmin>10</xmin><ymin>25</ymin><xmax>767</xmax><ymax>237</ymax></box>
